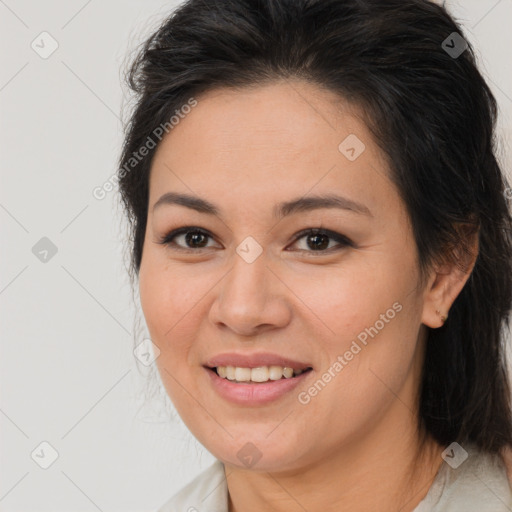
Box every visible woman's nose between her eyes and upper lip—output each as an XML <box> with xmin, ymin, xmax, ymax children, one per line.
<box><xmin>209</xmin><ymin>247</ymin><xmax>291</xmax><ymax>336</ymax></box>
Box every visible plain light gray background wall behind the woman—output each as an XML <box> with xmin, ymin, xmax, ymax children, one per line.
<box><xmin>0</xmin><ymin>0</ymin><xmax>512</xmax><ymax>512</ymax></box>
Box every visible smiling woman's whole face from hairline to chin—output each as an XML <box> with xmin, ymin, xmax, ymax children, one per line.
<box><xmin>140</xmin><ymin>81</ymin><xmax>432</xmax><ymax>470</ymax></box>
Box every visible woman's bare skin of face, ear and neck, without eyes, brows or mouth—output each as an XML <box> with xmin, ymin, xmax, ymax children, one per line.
<box><xmin>139</xmin><ymin>81</ymin><xmax>474</xmax><ymax>512</ymax></box>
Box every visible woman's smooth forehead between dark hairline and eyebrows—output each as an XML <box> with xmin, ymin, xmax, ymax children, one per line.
<box><xmin>150</xmin><ymin>81</ymin><xmax>392</xmax><ymax>214</ymax></box>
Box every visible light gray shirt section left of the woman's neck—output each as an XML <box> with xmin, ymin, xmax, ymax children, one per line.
<box><xmin>157</xmin><ymin>460</ymin><xmax>228</xmax><ymax>512</ymax></box>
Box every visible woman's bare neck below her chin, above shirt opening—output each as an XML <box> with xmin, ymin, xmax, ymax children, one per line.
<box><xmin>225</xmin><ymin>412</ymin><xmax>442</xmax><ymax>512</ymax></box>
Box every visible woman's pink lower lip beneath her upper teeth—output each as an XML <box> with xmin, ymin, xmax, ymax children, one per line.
<box><xmin>205</xmin><ymin>368</ymin><xmax>312</xmax><ymax>405</ymax></box>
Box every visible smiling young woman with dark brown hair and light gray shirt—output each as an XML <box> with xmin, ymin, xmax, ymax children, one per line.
<box><xmin>119</xmin><ymin>0</ymin><xmax>512</xmax><ymax>512</ymax></box>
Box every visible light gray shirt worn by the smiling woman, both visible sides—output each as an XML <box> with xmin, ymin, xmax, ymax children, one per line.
<box><xmin>157</xmin><ymin>446</ymin><xmax>512</xmax><ymax>512</ymax></box>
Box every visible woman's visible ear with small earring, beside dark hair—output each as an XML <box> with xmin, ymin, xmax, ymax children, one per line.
<box><xmin>422</xmin><ymin>224</ymin><xmax>479</xmax><ymax>328</ymax></box>
